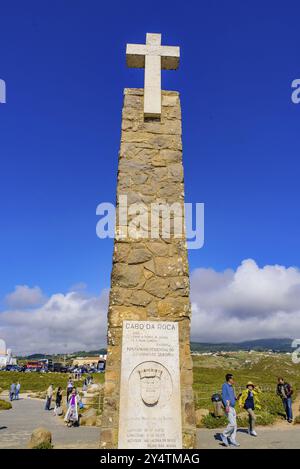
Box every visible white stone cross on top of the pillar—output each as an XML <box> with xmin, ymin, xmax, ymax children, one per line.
<box><xmin>126</xmin><ymin>33</ymin><xmax>179</xmax><ymax>118</ymax></box>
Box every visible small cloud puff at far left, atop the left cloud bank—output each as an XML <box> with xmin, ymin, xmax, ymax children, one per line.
<box><xmin>5</xmin><ymin>285</ymin><xmax>45</xmax><ymax>308</ymax></box>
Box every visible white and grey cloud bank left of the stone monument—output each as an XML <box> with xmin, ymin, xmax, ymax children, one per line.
<box><xmin>0</xmin><ymin>290</ymin><xmax>108</xmax><ymax>354</ymax></box>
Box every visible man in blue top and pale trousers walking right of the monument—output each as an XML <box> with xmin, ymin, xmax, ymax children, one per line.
<box><xmin>220</xmin><ymin>373</ymin><xmax>240</xmax><ymax>446</ymax></box>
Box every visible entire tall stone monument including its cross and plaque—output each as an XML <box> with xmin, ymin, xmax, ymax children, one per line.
<box><xmin>101</xmin><ymin>34</ymin><xmax>196</xmax><ymax>449</ymax></box>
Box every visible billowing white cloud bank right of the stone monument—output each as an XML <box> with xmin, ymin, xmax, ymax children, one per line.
<box><xmin>191</xmin><ymin>259</ymin><xmax>300</xmax><ymax>342</ymax></box>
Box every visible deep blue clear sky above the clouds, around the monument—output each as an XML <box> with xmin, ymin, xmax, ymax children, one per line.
<box><xmin>0</xmin><ymin>0</ymin><xmax>300</xmax><ymax>304</ymax></box>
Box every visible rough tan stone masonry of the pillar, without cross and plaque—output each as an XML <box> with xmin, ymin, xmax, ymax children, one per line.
<box><xmin>101</xmin><ymin>89</ymin><xmax>195</xmax><ymax>448</ymax></box>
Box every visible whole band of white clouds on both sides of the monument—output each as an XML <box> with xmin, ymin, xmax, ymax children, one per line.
<box><xmin>0</xmin><ymin>259</ymin><xmax>300</xmax><ymax>354</ymax></box>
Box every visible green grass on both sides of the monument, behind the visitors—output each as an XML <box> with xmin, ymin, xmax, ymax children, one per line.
<box><xmin>0</xmin><ymin>352</ymin><xmax>300</xmax><ymax>428</ymax></box>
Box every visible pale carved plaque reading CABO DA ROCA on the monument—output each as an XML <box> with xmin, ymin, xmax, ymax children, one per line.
<box><xmin>118</xmin><ymin>321</ymin><xmax>182</xmax><ymax>449</ymax></box>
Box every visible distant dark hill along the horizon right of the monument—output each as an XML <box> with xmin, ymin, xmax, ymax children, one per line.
<box><xmin>191</xmin><ymin>339</ymin><xmax>292</xmax><ymax>352</ymax></box>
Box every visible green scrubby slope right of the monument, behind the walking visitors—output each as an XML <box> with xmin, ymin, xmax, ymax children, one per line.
<box><xmin>193</xmin><ymin>352</ymin><xmax>300</xmax><ymax>428</ymax></box>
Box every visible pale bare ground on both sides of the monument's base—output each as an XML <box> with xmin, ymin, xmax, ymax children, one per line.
<box><xmin>0</xmin><ymin>396</ymin><xmax>300</xmax><ymax>450</ymax></box>
